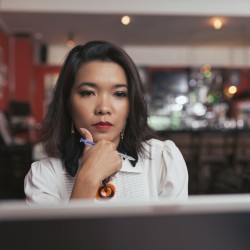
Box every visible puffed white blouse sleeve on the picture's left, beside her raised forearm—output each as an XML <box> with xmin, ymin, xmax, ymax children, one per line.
<box><xmin>24</xmin><ymin>158</ymin><xmax>61</xmax><ymax>204</ymax></box>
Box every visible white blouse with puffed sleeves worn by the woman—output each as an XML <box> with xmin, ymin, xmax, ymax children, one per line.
<box><xmin>24</xmin><ymin>139</ymin><xmax>188</xmax><ymax>204</ymax></box>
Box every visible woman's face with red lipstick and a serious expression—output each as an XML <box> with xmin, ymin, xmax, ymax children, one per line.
<box><xmin>70</xmin><ymin>60</ymin><xmax>129</xmax><ymax>146</ymax></box>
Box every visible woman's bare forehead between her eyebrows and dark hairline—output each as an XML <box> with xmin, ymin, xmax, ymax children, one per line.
<box><xmin>76</xmin><ymin>60</ymin><xmax>127</xmax><ymax>83</ymax></box>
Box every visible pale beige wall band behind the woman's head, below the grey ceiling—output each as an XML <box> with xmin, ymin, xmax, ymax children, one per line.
<box><xmin>47</xmin><ymin>45</ymin><xmax>250</xmax><ymax>68</ymax></box>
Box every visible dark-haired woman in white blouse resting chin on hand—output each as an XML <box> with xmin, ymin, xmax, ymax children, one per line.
<box><xmin>25</xmin><ymin>41</ymin><xmax>188</xmax><ymax>204</ymax></box>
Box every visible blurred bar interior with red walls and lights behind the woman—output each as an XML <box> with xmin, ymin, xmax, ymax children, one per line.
<box><xmin>0</xmin><ymin>0</ymin><xmax>250</xmax><ymax>199</ymax></box>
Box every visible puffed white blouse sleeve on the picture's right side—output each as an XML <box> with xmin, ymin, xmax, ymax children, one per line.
<box><xmin>158</xmin><ymin>140</ymin><xmax>188</xmax><ymax>200</ymax></box>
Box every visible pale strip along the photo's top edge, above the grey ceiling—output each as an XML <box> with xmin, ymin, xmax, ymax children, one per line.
<box><xmin>0</xmin><ymin>0</ymin><xmax>250</xmax><ymax>16</ymax></box>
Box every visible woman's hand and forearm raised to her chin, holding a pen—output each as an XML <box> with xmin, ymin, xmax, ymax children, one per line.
<box><xmin>71</xmin><ymin>129</ymin><xmax>122</xmax><ymax>198</ymax></box>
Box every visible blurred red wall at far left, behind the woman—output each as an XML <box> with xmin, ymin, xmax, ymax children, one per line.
<box><xmin>0</xmin><ymin>28</ymin><xmax>60</xmax><ymax>123</ymax></box>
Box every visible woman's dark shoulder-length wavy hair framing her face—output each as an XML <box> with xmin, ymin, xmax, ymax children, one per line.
<box><xmin>42</xmin><ymin>41</ymin><xmax>157</xmax><ymax>173</ymax></box>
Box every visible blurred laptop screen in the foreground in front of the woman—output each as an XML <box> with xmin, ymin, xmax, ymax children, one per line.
<box><xmin>0</xmin><ymin>196</ymin><xmax>250</xmax><ymax>250</ymax></box>
